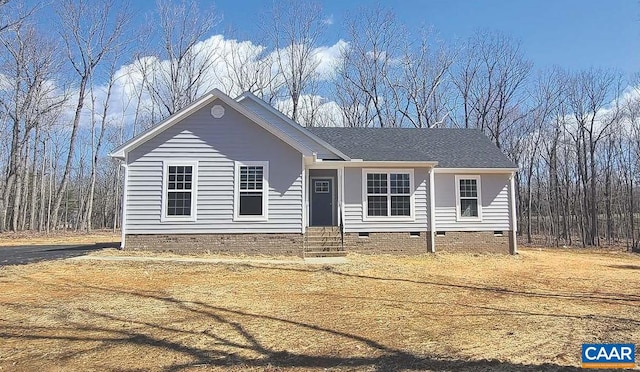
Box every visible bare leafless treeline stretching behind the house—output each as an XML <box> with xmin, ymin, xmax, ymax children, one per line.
<box><xmin>0</xmin><ymin>0</ymin><xmax>640</xmax><ymax>246</ymax></box>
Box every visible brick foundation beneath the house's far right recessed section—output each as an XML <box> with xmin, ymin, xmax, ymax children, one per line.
<box><xmin>436</xmin><ymin>231</ymin><xmax>512</xmax><ymax>254</ymax></box>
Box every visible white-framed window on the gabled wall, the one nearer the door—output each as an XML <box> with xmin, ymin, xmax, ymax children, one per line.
<box><xmin>234</xmin><ymin>162</ymin><xmax>269</xmax><ymax>220</ymax></box>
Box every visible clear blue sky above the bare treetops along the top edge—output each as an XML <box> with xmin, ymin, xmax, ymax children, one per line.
<box><xmin>127</xmin><ymin>0</ymin><xmax>640</xmax><ymax>74</ymax></box>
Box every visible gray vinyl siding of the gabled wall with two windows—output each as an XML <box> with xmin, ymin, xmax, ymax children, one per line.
<box><xmin>126</xmin><ymin>100</ymin><xmax>302</xmax><ymax>234</ymax></box>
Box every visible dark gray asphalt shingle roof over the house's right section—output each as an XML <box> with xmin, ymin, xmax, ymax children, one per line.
<box><xmin>307</xmin><ymin>128</ymin><xmax>516</xmax><ymax>168</ymax></box>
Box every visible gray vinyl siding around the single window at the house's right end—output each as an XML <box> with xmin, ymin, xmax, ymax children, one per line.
<box><xmin>435</xmin><ymin>173</ymin><xmax>510</xmax><ymax>231</ymax></box>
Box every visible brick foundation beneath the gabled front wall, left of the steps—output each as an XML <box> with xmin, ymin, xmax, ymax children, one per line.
<box><xmin>125</xmin><ymin>234</ymin><xmax>303</xmax><ymax>257</ymax></box>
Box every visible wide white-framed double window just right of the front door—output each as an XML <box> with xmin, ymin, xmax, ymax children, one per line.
<box><xmin>364</xmin><ymin>171</ymin><xmax>412</xmax><ymax>217</ymax></box>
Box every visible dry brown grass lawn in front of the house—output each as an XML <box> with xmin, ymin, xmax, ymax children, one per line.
<box><xmin>0</xmin><ymin>249</ymin><xmax>640</xmax><ymax>371</ymax></box>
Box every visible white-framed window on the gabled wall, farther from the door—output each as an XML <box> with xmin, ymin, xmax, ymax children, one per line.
<box><xmin>161</xmin><ymin>161</ymin><xmax>198</xmax><ymax>221</ymax></box>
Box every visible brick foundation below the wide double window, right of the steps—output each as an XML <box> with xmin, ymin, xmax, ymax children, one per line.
<box><xmin>344</xmin><ymin>231</ymin><xmax>429</xmax><ymax>255</ymax></box>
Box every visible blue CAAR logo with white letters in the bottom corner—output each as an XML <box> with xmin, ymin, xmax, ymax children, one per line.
<box><xmin>582</xmin><ymin>344</ymin><xmax>636</xmax><ymax>368</ymax></box>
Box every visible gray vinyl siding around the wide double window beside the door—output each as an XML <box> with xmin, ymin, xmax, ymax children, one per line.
<box><xmin>344</xmin><ymin>168</ymin><xmax>429</xmax><ymax>232</ymax></box>
